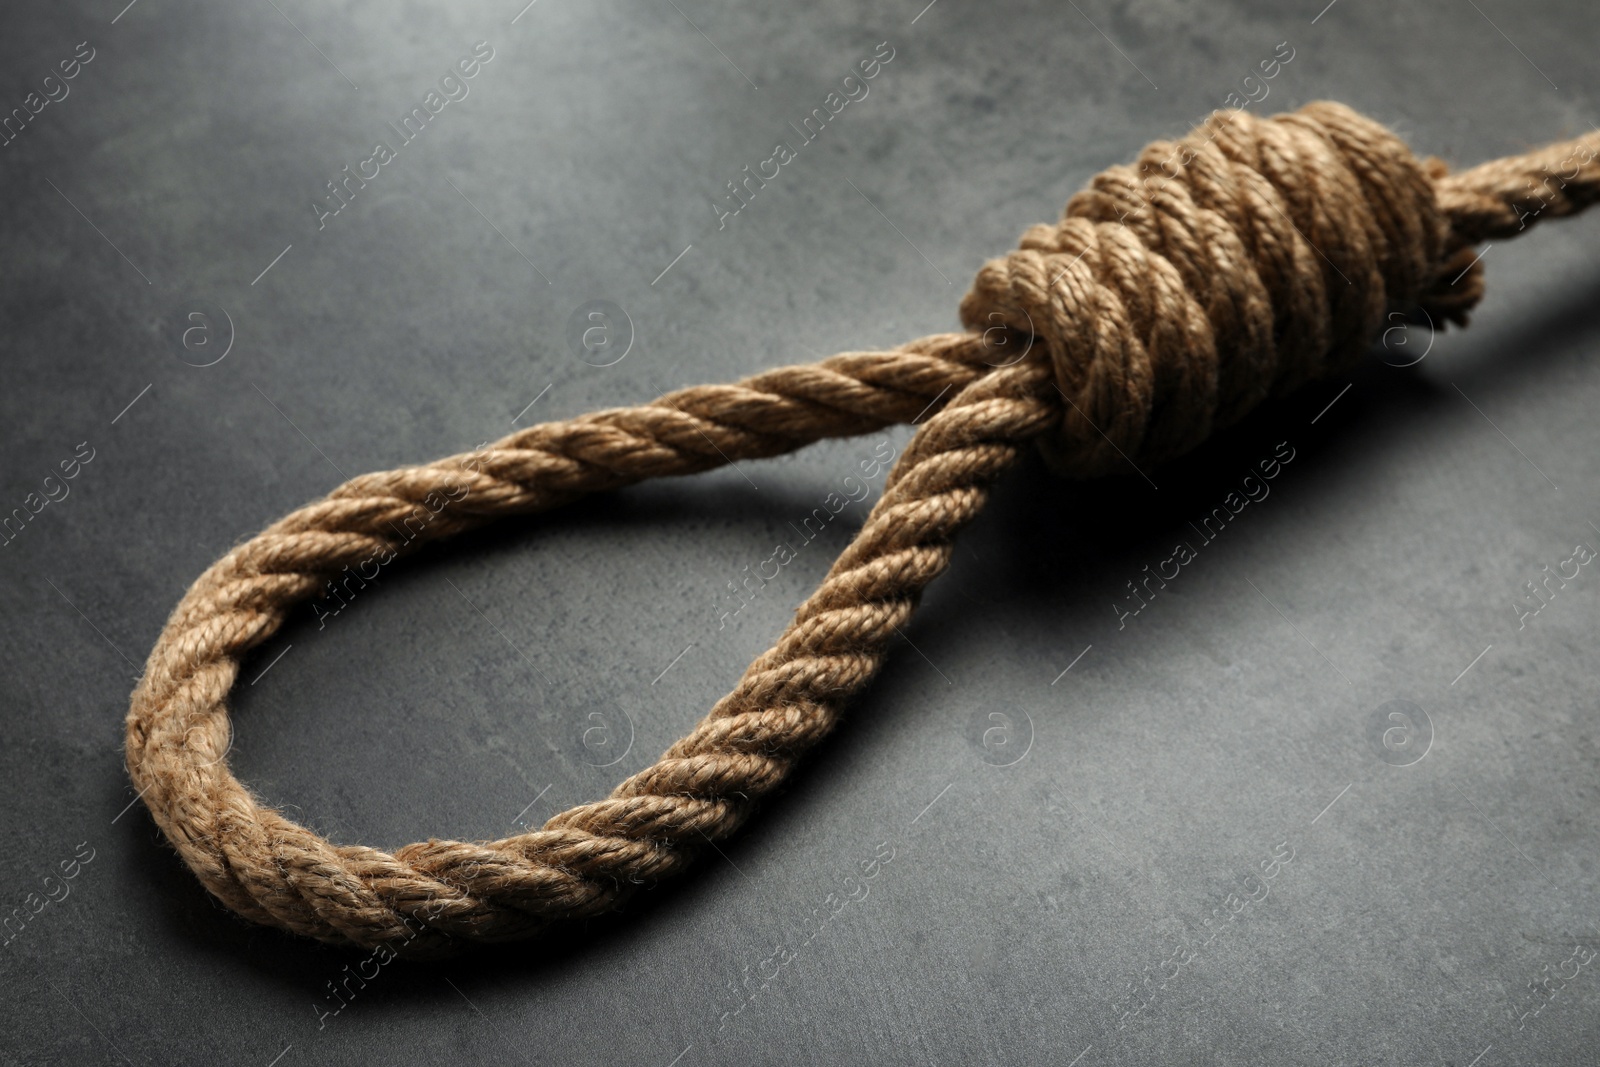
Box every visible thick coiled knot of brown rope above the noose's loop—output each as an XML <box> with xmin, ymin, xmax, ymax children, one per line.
<box><xmin>962</xmin><ymin>102</ymin><xmax>1482</xmax><ymax>477</ymax></box>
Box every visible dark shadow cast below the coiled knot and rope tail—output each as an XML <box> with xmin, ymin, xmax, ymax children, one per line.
<box><xmin>953</xmin><ymin>259</ymin><xmax>1600</xmax><ymax>627</ymax></box>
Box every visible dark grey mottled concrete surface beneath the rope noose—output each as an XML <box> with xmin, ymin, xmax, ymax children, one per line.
<box><xmin>0</xmin><ymin>0</ymin><xmax>1600</xmax><ymax>1067</ymax></box>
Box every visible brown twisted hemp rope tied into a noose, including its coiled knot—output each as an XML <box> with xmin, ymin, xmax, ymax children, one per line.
<box><xmin>126</xmin><ymin>102</ymin><xmax>1600</xmax><ymax>955</ymax></box>
